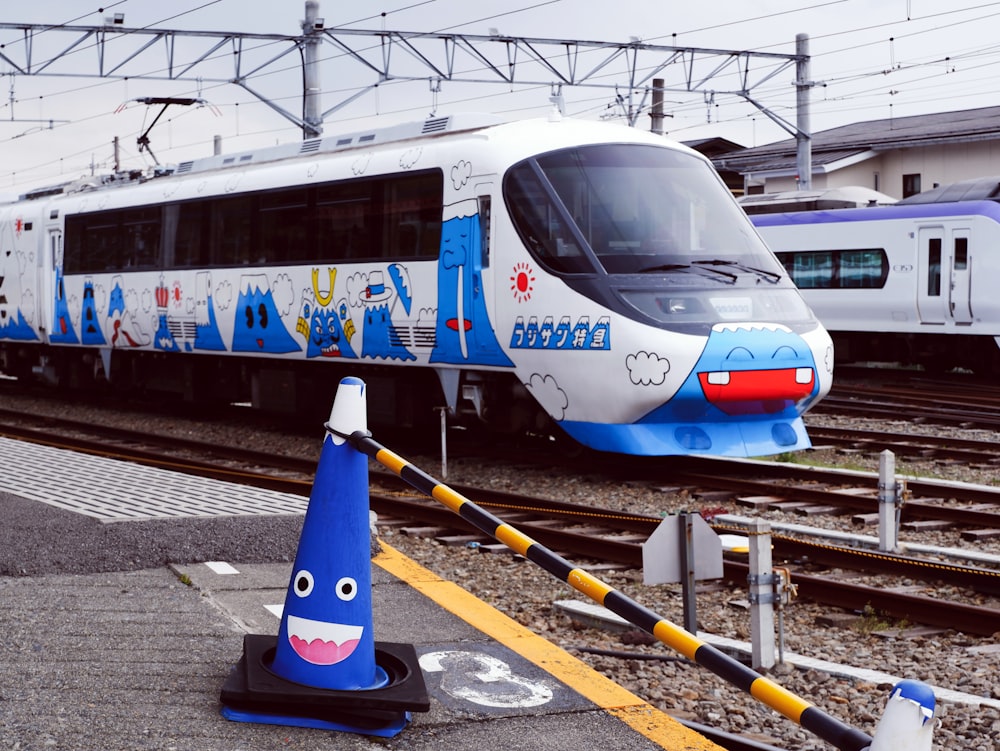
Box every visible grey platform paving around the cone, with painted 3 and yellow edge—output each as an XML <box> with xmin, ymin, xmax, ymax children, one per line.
<box><xmin>0</xmin><ymin>545</ymin><xmax>720</xmax><ymax>751</ymax></box>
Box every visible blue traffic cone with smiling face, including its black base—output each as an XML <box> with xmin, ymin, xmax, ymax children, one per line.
<box><xmin>221</xmin><ymin>377</ymin><xmax>430</xmax><ymax>736</ymax></box>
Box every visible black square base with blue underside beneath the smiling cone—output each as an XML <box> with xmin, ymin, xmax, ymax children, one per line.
<box><xmin>220</xmin><ymin>634</ymin><xmax>430</xmax><ymax>736</ymax></box>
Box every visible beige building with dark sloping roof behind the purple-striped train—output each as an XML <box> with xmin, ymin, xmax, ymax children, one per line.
<box><xmin>712</xmin><ymin>107</ymin><xmax>1000</xmax><ymax>198</ymax></box>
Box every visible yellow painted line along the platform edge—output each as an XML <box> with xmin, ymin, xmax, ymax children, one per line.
<box><xmin>372</xmin><ymin>541</ymin><xmax>721</xmax><ymax>751</ymax></box>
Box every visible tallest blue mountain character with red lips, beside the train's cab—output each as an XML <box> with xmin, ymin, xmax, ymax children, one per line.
<box><xmin>430</xmin><ymin>200</ymin><xmax>513</xmax><ymax>367</ymax></box>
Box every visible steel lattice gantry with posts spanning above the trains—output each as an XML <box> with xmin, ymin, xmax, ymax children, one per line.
<box><xmin>0</xmin><ymin>0</ymin><xmax>813</xmax><ymax>187</ymax></box>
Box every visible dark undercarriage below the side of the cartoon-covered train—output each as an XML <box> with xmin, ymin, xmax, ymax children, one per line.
<box><xmin>0</xmin><ymin>342</ymin><xmax>548</xmax><ymax>434</ymax></box>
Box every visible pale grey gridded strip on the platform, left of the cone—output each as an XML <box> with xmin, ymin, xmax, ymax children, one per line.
<box><xmin>0</xmin><ymin>438</ymin><xmax>309</xmax><ymax>522</ymax></box>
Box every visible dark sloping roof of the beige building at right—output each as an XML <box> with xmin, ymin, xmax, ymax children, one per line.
<box><xmin>713</xmin><ymin>107</ymin><xmax>1000</xmax><ymax>172</ymax></box>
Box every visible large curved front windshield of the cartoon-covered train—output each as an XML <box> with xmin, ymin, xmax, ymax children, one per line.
<box><xmin>504</xmin><ymin>144</ymin><xmax>812</xmax><ymax>324</ymax></box>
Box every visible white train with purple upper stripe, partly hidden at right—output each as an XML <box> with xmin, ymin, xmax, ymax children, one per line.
<box><xmin>751</xmin><ymin>178</ymin><xmax>1000</xmax><ymax>373</ymax></box>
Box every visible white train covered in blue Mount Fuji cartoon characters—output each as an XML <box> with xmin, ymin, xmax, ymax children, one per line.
<box><xmin>0</xmin><ymin>116</ymin><xmax>833</xmax><ymax>456</ymax></box>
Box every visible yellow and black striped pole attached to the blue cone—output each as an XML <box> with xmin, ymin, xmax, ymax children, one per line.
<box><xmin>346</xmin><ymin>426</ymin><xmax>872</xmax><ymax>751</ymax></box>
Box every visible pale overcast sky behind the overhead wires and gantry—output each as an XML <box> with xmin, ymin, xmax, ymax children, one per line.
<box><xmin>0</xmin><ymin>0</ymin><xmax>1000</xmax><ymax>195</ymax></box>
